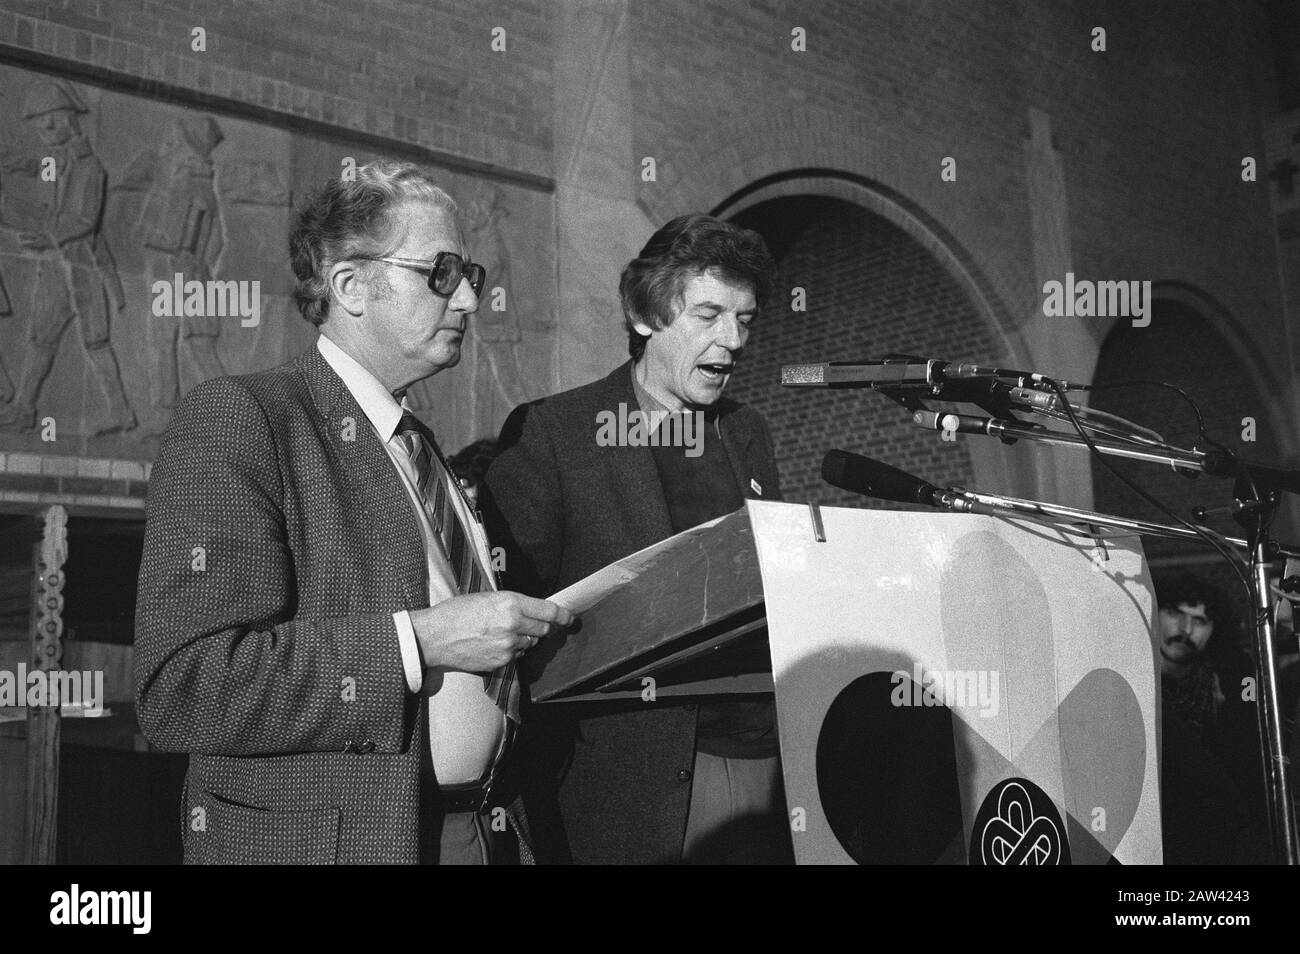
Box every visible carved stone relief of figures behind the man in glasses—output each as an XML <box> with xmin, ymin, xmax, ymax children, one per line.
<box><xmin>0</xmin><ymin>64</ymin><xmax>555</xmax><ymax>460</ymax></box>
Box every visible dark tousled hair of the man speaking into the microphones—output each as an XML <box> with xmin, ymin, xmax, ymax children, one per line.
<box><xmin>619</xmin><ymin>213</ymin><xmax>776</xmax><ymax>361</ymax></box>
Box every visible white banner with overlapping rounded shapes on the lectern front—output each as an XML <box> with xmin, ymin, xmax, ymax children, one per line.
<box><xmin>748</xmin><ymin>500</ymin><xmax>1162</xmax><ymax>864</ymax></box>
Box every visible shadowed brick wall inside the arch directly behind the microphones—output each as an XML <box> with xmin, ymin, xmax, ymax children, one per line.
<box><xmin>728</xmin><ymin>198</ymin><xmax>996</xmax><ymax>508</ymax></box>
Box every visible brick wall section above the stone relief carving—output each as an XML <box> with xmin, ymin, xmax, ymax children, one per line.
<box><xmin>0</xmin><ymin>0</ymin><xmax>554</xmax><ymax>177</ymax></box>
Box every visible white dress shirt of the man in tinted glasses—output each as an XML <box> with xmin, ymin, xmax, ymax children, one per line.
<box><xmin>316</xmin><ymin>334</ymin><xmax>506</xmax><ymax>785</ymax></box>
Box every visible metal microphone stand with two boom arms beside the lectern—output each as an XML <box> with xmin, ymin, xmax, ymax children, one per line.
<box><xmin>918</xmin><ymin>419</ymin><xmax>1300</xmax><ymax>864</ymax></box>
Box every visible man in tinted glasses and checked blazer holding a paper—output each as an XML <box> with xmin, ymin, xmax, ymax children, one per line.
<box><xmin>135</xmin><ymin>161</ymin><xmax>572</xmax><ymax>864</ymax></box>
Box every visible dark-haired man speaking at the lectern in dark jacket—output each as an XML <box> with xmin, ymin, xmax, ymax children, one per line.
<box><xmin>485</xmin><ymin>214</ymin><xmax>790</xmax><ymax>863</ymax></box>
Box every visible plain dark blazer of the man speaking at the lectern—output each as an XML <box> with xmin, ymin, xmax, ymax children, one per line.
<box><xmin>482</xmin><ymin>363</ymin><xmax>780</xmax><ymax>863</ymax></box>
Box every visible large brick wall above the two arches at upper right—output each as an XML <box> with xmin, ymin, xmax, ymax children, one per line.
<box><xmin>633</xmin><ymin>0</ymin><xmax>1291</xmax><ymax>415</ymax></box>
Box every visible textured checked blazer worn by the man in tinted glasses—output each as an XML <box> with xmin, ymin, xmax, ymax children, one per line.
<box><xmin>135</xmin><ymin>347</ymin><xmax>429</xmax><ymax>863</ymax></box>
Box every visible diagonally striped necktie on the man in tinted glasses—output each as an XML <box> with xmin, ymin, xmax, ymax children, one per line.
<box><xmin>397</xmin><ymin>412</ymin><xmax>519</xmax><ymax>721</ymax></box>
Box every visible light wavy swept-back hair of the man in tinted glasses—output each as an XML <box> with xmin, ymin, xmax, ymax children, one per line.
<box><xmin>289</xmin><ymin>159</ymin><xmax>459</xmax><ymax>326</ymax></box>
